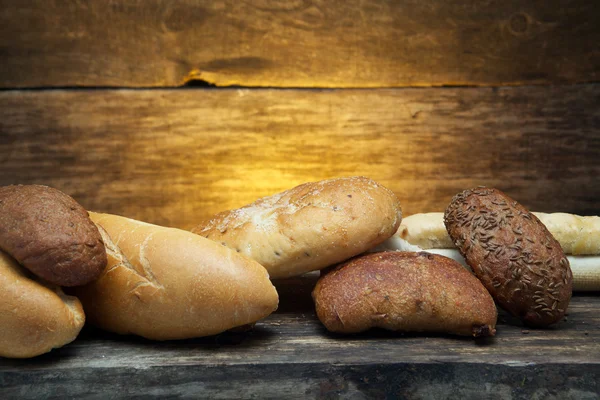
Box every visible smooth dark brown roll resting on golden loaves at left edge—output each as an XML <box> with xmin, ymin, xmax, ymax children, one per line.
<box><xmin>0</xmin><ymin>185</ymin><xmax>107</xmax><ymax>286</ymax></box>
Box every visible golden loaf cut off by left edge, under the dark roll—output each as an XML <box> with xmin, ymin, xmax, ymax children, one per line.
<box><xmin>0</xmin><ymin>251</ymin><xmax>85</xmax><ymax>358</ymax></box>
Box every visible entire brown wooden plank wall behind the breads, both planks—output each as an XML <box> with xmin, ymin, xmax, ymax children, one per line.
<box><xmin>0</xmin><ymin>0</ymin><xmax>600</xmax><ymax>228</ymax></box>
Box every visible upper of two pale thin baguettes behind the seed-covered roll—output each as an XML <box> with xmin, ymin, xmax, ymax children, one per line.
<box><xmin>395</xmin><ymin>212</ymin><xmax>600</xmax><ymax>255</ymax></box>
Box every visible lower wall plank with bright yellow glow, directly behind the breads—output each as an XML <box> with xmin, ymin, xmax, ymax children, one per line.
<box><xmin>0</xmin><ymin>84</ymin><xmax>600</xmax><ymax>228</ymax></box>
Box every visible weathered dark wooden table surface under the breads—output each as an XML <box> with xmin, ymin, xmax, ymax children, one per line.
<box><xmin>0</xmin><ymin>276</ymin><xmax>600</xmax><ymax>399</ymax></box>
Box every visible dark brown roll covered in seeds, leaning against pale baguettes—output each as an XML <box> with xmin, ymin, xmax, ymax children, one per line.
<box><xmin>444</xmin><ymin>188</ymin><xmax>573</xmax><ymax>327</ymax></box>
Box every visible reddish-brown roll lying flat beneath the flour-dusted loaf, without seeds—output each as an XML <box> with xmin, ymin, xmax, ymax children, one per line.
<box><xmin>313</xmin><ymin>251</ymin><xmax>497</xmax><ymax>336</ymax></box>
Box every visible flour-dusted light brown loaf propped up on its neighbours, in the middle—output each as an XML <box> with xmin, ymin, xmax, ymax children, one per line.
<box><xmin>192</xmin><ymin>177</ymin><xmax>402</xmax><ymax>278</ymax></box>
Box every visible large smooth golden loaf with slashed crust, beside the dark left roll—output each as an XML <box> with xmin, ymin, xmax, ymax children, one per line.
<box><xmin>75</xmin><ymin>213</ymin><xmax>278</xmax><ymax>340</ymax></box>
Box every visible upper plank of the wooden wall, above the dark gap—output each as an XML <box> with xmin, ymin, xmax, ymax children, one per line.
<box><xmin>0</xmin><ymin>0</ymin><xmax>600</xmax><ymax>87</ymax></box>
